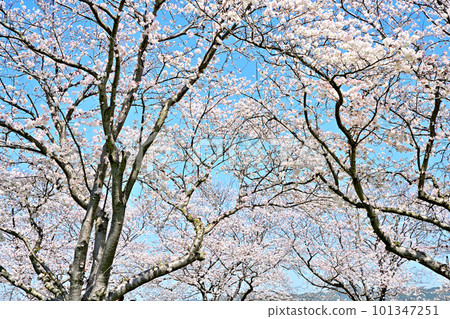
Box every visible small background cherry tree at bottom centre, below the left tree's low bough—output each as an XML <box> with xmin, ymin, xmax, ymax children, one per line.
<box><xmin>148</xmin><ymin>185</ymin><xmax>294</xmax><ymax>301</ymax></box>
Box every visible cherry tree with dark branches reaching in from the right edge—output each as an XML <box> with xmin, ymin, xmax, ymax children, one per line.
<box><xmin>241</xmin><ymin>0</ymin><xmax>450</xmax><ymax>279</ymax></box>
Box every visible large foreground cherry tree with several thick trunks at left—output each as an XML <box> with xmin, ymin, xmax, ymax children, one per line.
<box><xmin>0</xmin><ymin>0</ymin><xmax>268</xmax><ymax>300</ymax></box>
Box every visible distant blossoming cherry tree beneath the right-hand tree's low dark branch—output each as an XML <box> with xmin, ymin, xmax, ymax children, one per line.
<box><xmin>283</xmin><ymin>208</ymin><xmax>428</xmax><ymax>301</ymax></box>
